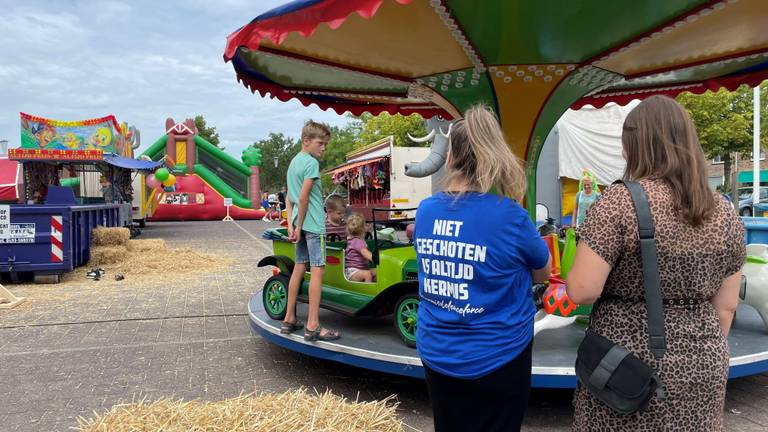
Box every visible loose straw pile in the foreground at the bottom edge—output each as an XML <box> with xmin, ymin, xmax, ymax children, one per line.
<box><xmin>77</xmin><ymin>389</ymin><xmax>403</xmax><ymax>432</ymax></box>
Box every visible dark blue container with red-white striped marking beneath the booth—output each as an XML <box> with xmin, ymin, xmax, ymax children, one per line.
<box><xmin>0</xmin><ymin>204</ymin><xmax>120</xmax><ymax>277</ymax></box>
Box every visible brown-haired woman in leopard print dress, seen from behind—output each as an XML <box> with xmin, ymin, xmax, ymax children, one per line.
<box><xmin>567</xmin><ymin>96</ymin><xmax>745</xmax><ymax>432</ymax></box>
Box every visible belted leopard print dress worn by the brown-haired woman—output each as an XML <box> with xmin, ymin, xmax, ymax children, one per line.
<box><xmin>573</xmin><ymin>180</ymin><xmax>745</xmax><ymax>432</ymax></box>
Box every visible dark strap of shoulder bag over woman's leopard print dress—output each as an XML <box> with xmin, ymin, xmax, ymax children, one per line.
<box><xmin>615</xmin><ymin>180</ymin><xmax>667</xmax><ymax>358</ymax></box>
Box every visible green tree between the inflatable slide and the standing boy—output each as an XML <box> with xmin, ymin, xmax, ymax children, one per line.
<box><xmin>253</xmin><ymin>133</ymin><xmax>301</xmax><ymax>192</ymax></box>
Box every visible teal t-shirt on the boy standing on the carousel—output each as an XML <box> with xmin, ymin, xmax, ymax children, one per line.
<box><xmin>287</xmin><ymin>151</ymin><xmax>325</xmax><ymax>234</ymax></box>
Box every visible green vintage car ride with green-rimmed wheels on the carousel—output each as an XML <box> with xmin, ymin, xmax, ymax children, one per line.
<box><xmin>258</xmin><ymin>224</ymin><xmax>419</xmax><ymax>347</ymax></box>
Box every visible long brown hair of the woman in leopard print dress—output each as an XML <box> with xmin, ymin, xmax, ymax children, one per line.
<box><xmin>621</xmin><ymin>96</ymin><xmax>715</xmax><ymax>226</ymax></box>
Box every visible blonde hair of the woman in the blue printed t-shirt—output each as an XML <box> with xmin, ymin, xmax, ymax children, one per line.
<box><xmin>443</xmin><ymin>105</ymin><xmax>526</xmax><ymax>201</ymax></box>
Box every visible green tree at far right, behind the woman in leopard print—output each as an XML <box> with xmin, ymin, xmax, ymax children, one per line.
<box><xmin>677</xmin><ymin>83</ymin><xmax>768</xmax><ymax>190</ymax></box>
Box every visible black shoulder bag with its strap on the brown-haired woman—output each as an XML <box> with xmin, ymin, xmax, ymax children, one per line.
<box><xmin>576</xmin><ymin>181</ymin><xmax>667</xmax><ymax>414</ymax></box>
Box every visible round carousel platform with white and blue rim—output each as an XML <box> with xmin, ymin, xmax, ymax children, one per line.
<box><xmin>248</xmin><ymin>291</ymin><xmax>768</xmax><ymax>388</ymax></box>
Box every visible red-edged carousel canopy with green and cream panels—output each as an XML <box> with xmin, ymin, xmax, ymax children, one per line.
<box><xmin>224</xmin><ymin>0</ymin><xmax>768</xmax><ymax>209</ymax></box>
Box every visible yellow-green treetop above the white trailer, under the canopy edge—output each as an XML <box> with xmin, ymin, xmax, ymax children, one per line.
<box><xmin>358</xmin><ymin>112</ymin><xmax>430</xmax><ymax>147</ymax></box>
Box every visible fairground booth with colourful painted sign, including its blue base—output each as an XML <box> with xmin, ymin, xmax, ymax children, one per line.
<box><xmin>0</xmin><ymin>113</ymin><xmax>161</xmax><ymax>280</ymax></box>
